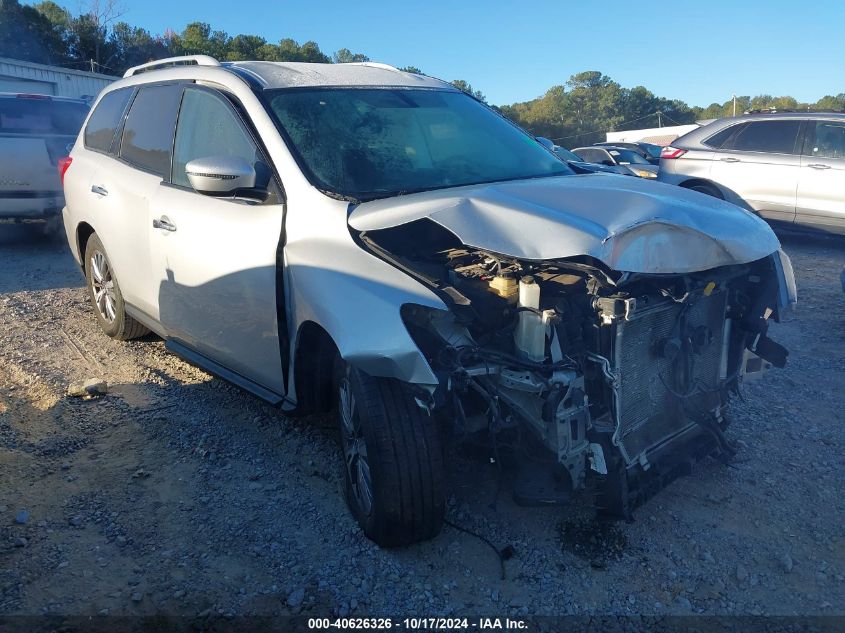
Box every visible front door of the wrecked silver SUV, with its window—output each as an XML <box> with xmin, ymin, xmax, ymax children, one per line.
<box><xmin>146</xmin><ymin>86</ymin><xmax>285</xmax><ymax>397</ymax></box>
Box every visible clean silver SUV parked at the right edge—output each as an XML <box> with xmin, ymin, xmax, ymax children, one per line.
<box><xmin>659</xmin><ymin>112</ymin><xmax>845</xmax><ymax>234</ymax></box>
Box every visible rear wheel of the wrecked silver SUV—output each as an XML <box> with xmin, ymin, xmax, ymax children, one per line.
<box><xmin>84</xmin><ymin>233</ymin><xmax>149</xmax><ymax>341</ymax></box>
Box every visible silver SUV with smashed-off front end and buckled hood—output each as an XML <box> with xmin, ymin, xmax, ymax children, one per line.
<box><xmin>63</xmin><ymin>57</ymin><xmax>795</xmax><ymax>546</ymax></box>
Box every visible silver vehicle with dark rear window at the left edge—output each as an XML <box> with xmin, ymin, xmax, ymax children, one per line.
<box><xmin>0</xmin><ymin>93</ymin><xmax>88</xmax><ymax>219</ymax></box>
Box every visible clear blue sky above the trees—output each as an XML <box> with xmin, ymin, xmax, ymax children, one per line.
<box><xmin>82</xmin><ymin>0</ymin><xmax>845</xmax><ymax>106</ymax></box>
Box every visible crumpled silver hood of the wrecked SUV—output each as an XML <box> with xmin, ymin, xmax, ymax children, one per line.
<box><xmin>349</xmin><ymin>174</ymin><xmax>780</xmax><ymax>274</ymax></box>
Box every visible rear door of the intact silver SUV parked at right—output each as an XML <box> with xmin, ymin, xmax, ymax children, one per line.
<box><xmin>710</xmin><ymin>119</ymin><xmax>801</xmax><ymax>222</ymax></box>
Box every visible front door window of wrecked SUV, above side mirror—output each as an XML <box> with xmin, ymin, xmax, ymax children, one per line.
<box><xmin>173</xmin><ymin>89</ymin><xmax>257</xmax><ymax>187</ymax></box>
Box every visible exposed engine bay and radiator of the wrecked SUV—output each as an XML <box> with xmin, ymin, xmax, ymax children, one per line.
<box><xmin>359</xmin><ymin>219</ymin><xmax>787</xmax><ymax>516</ymax></box>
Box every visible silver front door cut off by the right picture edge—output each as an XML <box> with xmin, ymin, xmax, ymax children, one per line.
<box><xmin>795</xmin><ymin>119</ymin><xmax>845</xmax><ymax>233</ymax></box>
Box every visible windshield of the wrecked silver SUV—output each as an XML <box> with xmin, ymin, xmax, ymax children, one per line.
<box><xmin>270</xmin><ymin>88</ymin><xmax>572</xmax><ymax>200</ymax></box>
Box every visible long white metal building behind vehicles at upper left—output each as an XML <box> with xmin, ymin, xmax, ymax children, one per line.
<box><xmin>0</xmin><ymin>57</ymin><xmax>114</xmax><ymax>100</ymax></box>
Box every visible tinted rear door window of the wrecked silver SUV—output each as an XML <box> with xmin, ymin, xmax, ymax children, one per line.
<box><xmin>120</xmin><ymin>85</ymin><xmax>182</xmax><ymax>176</ymax></box>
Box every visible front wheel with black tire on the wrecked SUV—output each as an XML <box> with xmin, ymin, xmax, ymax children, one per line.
<box><xmin>335</xmin><ymin>360</ymin><xmax>446</xmax><ymax>547</ymax></box>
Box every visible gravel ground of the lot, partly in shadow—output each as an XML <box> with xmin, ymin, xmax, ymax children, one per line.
<box><xmin>0</xmin><ymin>225</ymin><xmax>845</xmax><ymax>617</ymax></box>
